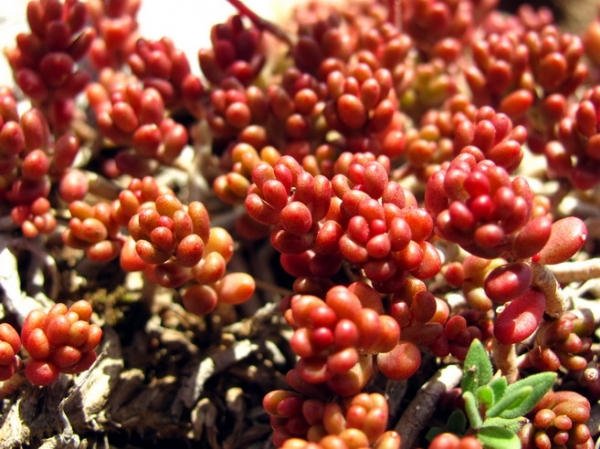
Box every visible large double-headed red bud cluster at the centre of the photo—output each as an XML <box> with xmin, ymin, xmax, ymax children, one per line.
<box><xmin>245</xmin><ymin>153</ymin><xmax>441</xmax><ymax>292</ymax></box>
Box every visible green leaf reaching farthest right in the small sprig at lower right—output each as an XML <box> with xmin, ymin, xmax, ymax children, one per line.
<box><xmin>486</xmin><ymin>373</ymin><xmax>556</xmax><ymax>418</ymax></box>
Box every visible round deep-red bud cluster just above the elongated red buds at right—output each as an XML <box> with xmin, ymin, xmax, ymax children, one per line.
<box><xmin>425</xmin><ymin>153</ymin><xmax>552</xmax><ymax>259</ymax></box>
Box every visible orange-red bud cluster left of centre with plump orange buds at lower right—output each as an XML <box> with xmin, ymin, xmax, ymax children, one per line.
<box><xmin>121</xmin><ymin>193</ymin><xmax>254</xmax><ymax>315</ymax></box>
